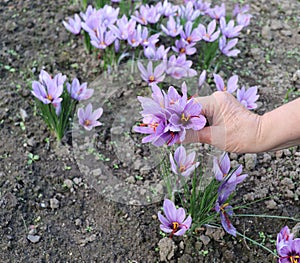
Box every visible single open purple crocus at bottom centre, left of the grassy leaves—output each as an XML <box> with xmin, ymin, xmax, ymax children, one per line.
<box><xmin>158</xmin><ymin>199</ymin><xmax>192</xmax><ymax>238</ymax></box>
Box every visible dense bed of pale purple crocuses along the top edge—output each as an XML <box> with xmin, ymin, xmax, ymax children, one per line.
<box><xmin>63</xmin><ymin>0</ymin><xmax>251</xmax><ymax>72</ymax></box>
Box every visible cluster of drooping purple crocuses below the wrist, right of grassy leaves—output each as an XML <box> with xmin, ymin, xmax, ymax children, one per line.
<box><xmin>213</xmin><ymin>153</ymin><xmax>248</xmax><ymax>236</ymax></box>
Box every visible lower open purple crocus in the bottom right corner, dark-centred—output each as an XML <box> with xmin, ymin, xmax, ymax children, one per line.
<box><xmin>277</xmin><ymin>238</ymin><xmax>300</xmax><ymax>263</ymax></box>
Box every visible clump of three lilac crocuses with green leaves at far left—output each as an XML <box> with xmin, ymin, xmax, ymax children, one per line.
<box><xmin>31</xmin><ymin>70</ymin><xmax>102</xmax><ymax>141</ymax></box>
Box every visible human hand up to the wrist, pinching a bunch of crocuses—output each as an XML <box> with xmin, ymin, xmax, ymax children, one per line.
<box><xmin>183</xmin><ymin>91</ymin><xmax>263</xmax><ymax>153</ymax></box>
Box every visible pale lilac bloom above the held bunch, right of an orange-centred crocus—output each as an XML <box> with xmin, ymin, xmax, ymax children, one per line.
<box><xmin>166</xmin><ymin>55</ymin><xmax>197</xmax><ymax>79</ymax></box>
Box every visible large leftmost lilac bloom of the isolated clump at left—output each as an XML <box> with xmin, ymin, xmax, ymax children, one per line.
<box><xmin>31</xmin><ymin>70</ymin><xmax>66</xmax><ymax>105</ymax></box>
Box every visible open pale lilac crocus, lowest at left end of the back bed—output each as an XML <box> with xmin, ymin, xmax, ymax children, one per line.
<box><xmin>91</xmin><ymin>26</ymin><xmax>116</xmax><ymax>49</ymax></box>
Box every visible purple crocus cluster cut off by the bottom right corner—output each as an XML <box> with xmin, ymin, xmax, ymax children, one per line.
<box><xmin>276</xmin><ymin>226</ymin><xmax>300</xmax><ymax>263</ymax></box>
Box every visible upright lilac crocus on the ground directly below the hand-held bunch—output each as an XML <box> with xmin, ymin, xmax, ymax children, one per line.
<box><xmin>170</xmin><ymin>146</ymin><xmax>200</xmax><ymax>176</ymax></box>
